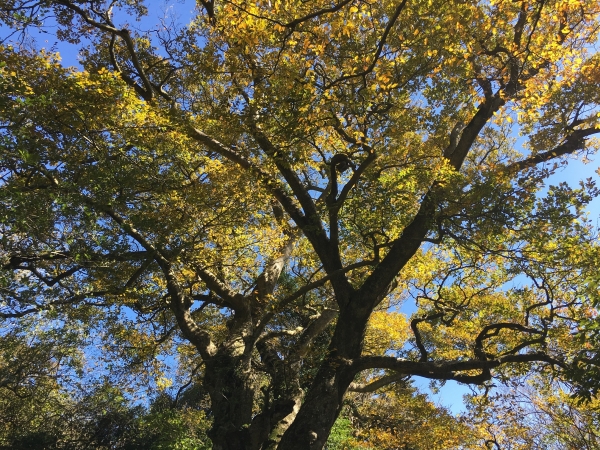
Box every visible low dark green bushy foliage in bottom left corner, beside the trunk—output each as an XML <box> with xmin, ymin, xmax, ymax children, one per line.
<box><xmin>0</xmin><ymin>378</ymin><xmax>211</xmax><ymax>450</ymax></box>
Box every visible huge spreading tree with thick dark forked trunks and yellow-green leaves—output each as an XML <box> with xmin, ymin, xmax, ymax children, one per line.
<box><xmin>0</xmin><ymin>0</ymin><xmax>600</xmax><ymax>450</ymax></box>
